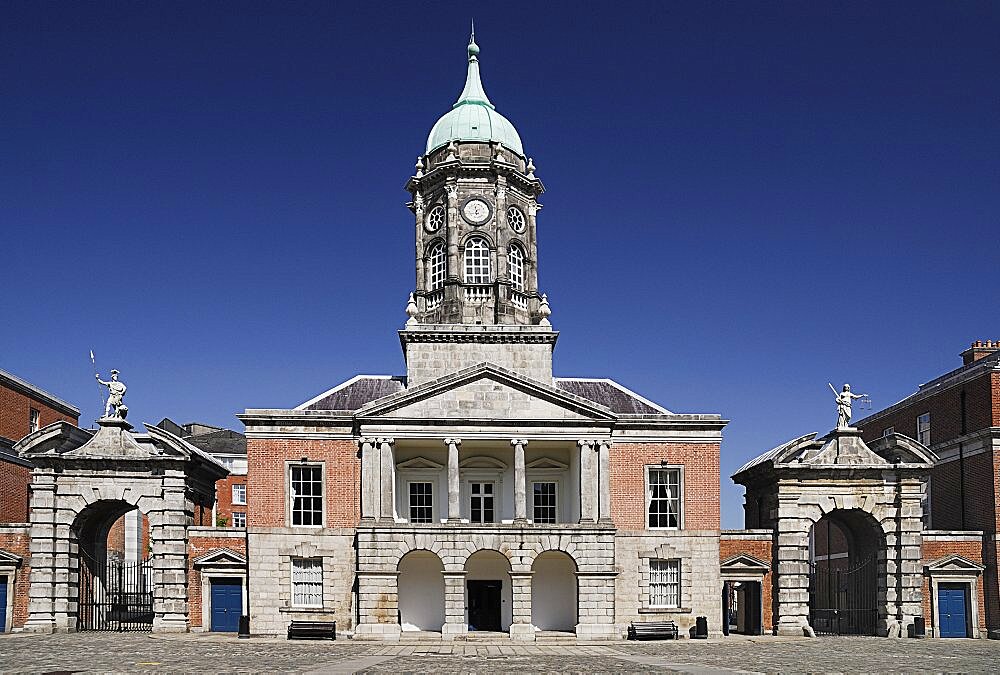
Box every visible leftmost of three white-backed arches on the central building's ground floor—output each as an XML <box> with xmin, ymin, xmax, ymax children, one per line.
<box><xmin>397</xmin><ymin>550</ymin><xmax>444</xmax><ymax>632</ymax></box>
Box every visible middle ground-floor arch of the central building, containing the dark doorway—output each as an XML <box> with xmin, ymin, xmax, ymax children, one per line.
<box><xmin>465</xmin><ymin>550</ymin><xmax>514</xmax><ymax>631</ymax></box>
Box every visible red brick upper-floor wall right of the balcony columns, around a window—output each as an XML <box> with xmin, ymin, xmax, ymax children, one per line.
<box><xmin>611</xmin><ymin>443</ymin><xmax>720</xmax><ymax>530</ymax></box>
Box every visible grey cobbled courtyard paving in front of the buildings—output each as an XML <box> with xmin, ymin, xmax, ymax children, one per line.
<box><xmin>0</xmin><ymin>633</ymin><xmax>1000</xmax><ymax>673</ymax></box>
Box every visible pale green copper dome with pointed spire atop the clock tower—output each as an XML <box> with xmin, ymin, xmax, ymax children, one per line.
<box><xmin>426</xmin><ymin>37</ymin><xmax>524</xmax><ymax>157</ymax></box>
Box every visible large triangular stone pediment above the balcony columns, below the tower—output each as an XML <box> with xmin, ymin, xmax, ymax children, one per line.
<box><xmin>358</xmin><ymin>363</ymin><xmax>617</xmax><ymax>421</ymax></box>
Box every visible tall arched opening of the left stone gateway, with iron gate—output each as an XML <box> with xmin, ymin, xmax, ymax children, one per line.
<box><xmin>72</xmin><ymin>500</ymin><xmax>153</xmax><ymax>632</ymax></box>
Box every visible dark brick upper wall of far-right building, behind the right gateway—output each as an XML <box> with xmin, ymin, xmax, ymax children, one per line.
<box><xmin>859</xmin><ymin>373</ymin><xmax>1000</xmax><ymax>445</ymax></box>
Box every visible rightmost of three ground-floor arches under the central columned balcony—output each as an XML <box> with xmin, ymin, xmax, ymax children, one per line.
<box><xmin>531</xmin><ymin>551</ymin><xmax>577</xmax><ymax>631</ymax></box>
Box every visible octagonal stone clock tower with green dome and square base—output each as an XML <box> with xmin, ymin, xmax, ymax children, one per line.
<box><xmin>400</xmin><ymin>34</ymin><xmax>557</xmax><ymax>384</ymax></box>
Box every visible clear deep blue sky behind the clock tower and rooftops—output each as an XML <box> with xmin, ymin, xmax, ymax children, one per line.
<box><xmin>0</xmin><ymin>2</ymin><xmax>1000</xmax><ymax>527</ymax></box>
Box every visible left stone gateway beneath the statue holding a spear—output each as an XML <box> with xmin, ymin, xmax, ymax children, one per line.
<box><xmin>15</xmin><ymin>418</ymin><xmax>228</xmax><ymax>633</ymax></box>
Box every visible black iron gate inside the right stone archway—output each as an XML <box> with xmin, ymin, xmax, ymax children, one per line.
<box><xmin>809</xmin><ymin>555</ymin><xmax>878</xmax><ymax>635</ymax></box>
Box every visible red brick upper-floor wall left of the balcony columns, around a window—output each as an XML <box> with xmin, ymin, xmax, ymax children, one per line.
<box><xmin>247</xmin><ymin>438</ymin><xmax>360</xmax><ymax>527</ymax></box>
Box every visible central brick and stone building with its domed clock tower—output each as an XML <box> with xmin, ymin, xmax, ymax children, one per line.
<box><xmin>239</xmin><ymin>34</ymin><xmax>726</xmax><ymax>640</ymax></box>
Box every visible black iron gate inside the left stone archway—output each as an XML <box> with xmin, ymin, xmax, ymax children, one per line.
<box><xmin>77</xmin><ymin>549</ymin><xmax>153</xmax><ymax>632</ymax></box>
